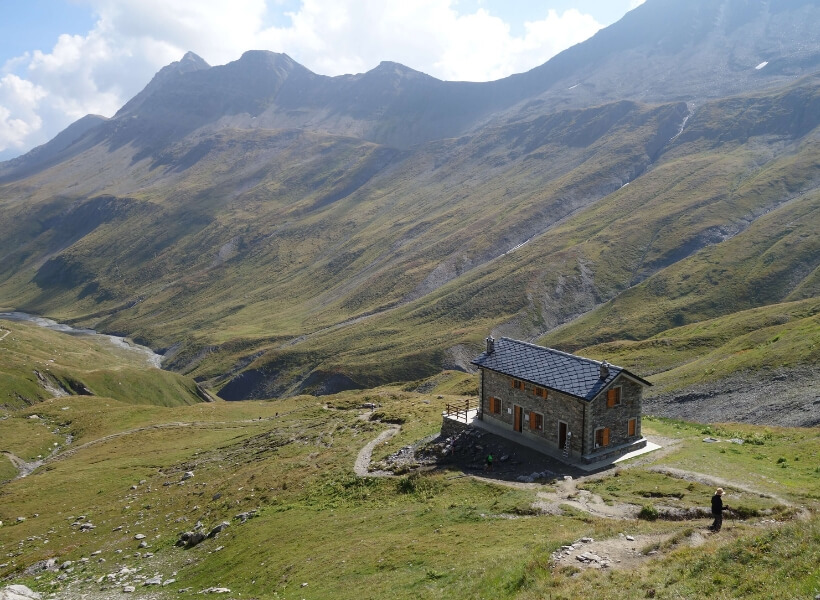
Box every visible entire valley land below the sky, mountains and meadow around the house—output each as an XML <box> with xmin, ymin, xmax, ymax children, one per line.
<box><xmin>0</xmin><ymin>0</ymin><xmax>820</xmax><ymax>598</ymax></box>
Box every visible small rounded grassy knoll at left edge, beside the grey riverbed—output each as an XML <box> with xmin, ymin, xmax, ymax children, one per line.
<box><xmin>0</xmin><ymin>320</ymin><xmax>202</xmax><ymax>411</ymax></box>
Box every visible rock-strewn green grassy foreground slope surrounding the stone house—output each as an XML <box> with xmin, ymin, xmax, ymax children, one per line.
<box><xmin>0</xmin><ymin>386</ymin><xmax>820</xmax><ymax>599</ymax></box>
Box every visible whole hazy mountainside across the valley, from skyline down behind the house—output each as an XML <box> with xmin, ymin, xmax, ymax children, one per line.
<box><xmin>0</xmin><ymin>0</ymin><xmax>820</xmax><ymax>399</ymax></box>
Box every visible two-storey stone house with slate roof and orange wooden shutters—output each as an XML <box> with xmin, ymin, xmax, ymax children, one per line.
<box><xmin>472</xmin><ymin>337</ymin><xmax>652</xmax><ymax>464</ymax></box>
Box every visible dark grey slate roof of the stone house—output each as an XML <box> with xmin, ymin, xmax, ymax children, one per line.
<box><xmin>472</xmin><ymin>337</ymin><xmax>652</xmax><ymax>400</ymax></box>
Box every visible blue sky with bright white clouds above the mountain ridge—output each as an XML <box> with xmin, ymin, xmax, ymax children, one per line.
<box><xmin>0</xmin><ymin>0</ymin><xmax>644</xmax><ymax>160</ymax></box>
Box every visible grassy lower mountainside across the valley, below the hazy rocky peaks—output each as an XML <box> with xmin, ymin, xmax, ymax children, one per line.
<box><xmin>0</xmin><ymin>79</ymin><xmax>820</xmax><ymax>398</ymax></box>
